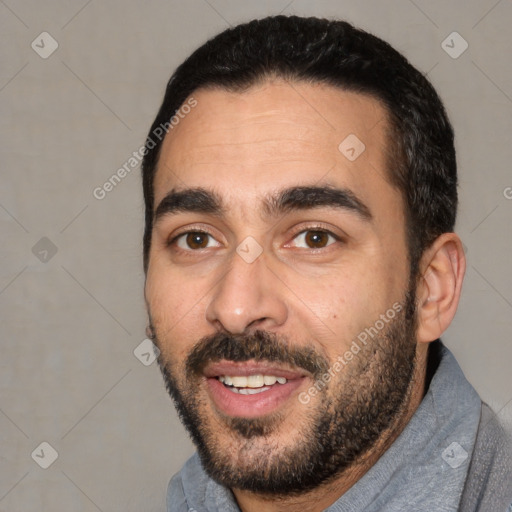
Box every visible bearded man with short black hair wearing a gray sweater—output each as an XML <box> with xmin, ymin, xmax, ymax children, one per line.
<box><xmin>143</xmin><ymin>16</ymin><xmax>512</xmax><ymax>512</ymax></box>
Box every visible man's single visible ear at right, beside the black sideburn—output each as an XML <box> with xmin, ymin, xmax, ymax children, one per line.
<box><xmin>416</xmin><ymin>233</ymin><xmax>466</xmax><ymax>343</ymax></box>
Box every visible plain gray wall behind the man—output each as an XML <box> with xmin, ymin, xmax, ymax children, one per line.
<box><xmin>0</xmin><ymin>0</ymin><xmax>512</xmax><ymax>512</ymax></box>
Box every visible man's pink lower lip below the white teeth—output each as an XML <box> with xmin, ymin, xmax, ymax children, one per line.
<box><xmin>206</xmin><ymin>377</ymin><xmax>305</xmax><ymax>418</ymax></box>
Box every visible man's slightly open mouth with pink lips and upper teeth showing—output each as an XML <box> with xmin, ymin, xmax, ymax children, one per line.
<box><xmin>203</xmin><ymin>361</ymin><xmax>308</xmax><ymax>418</ymax></box>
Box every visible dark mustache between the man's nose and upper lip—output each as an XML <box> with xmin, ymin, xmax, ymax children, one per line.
<box><xmin>185</xmin><ymin>330</ymin><xmax>329</xmax><ymax>378</ymax></box>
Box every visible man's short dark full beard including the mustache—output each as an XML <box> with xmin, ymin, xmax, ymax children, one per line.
<box><xmin>156</xmin><ymin>289</ymin><xmax>416</xmax><ymax>498</ymax></box>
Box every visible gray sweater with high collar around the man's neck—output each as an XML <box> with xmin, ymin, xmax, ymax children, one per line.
<box><xmin>167</xmin><ymin>341</ymin><xmax>512</xmax><ymax>512</ymax></box>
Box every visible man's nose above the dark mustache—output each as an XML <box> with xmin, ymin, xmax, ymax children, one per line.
<box><xmin>206</xmin><ymin>252</ymin><xmax>288</xmax><ymax>334</ymax></box>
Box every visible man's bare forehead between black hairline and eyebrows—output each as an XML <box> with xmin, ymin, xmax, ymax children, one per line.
<box><xmin>154</xmin><ymin>80</ymin><xmax>401</xmax><ymax>218</ymax></box>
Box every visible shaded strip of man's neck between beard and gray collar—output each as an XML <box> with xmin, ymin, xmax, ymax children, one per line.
<box><xmin>232</xmin><ymin>343</ymin><xmax>428</xmax><ymax>512</ymax></box>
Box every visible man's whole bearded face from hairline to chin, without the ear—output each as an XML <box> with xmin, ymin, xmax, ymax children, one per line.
<box><xmin>145</xmin><ymin>82</ymin><xmax>416</xmax><ymax>493</ymax></box>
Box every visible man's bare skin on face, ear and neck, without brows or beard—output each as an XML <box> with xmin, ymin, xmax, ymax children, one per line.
<box><xmin>145</xmin><ymin>80</ymin><xmax>465</xmax><ymax>512</ymax></box>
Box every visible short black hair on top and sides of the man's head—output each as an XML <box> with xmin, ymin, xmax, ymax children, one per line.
<box><xmin>142</xmin><ymin>15</ymin><xmax>457</xmax><ymax>276</ymax></box>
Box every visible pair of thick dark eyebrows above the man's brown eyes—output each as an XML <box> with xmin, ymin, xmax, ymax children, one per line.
<box><xmin>153</xmin><ymin>185</ymin><xmax>373</xmax><ymax>223</ymax></box>
